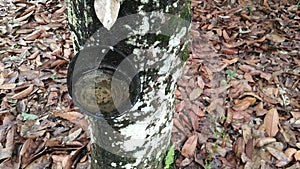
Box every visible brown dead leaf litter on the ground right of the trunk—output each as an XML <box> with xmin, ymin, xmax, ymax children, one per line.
<box><xmin>172</xmin><ymin>0</ymin><xmax>300</xmax><ymax>169</ymax></box>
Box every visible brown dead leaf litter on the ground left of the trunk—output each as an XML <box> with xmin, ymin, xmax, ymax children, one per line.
<box><xmin>0</xmin><ymin>0</ymin><xmax>89</xmax><ymax>169</ymax></box>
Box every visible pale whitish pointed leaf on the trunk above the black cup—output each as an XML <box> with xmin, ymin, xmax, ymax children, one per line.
<box><xmin>94</xmin><ymin>0</ymin><xmax>120</xmax><ymax>30</ymax></box>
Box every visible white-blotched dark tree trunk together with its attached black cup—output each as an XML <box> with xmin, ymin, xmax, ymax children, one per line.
<box><xmin>66</xmin><ymin>0</ymin><xmax>191</xmax><ymax>169</ymax></box>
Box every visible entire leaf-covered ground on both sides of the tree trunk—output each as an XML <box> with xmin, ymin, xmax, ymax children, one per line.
<box><xmin>0</xmin><ymin>0</ymin><xmax>300</xmax><ymax>169</ymax></box>
